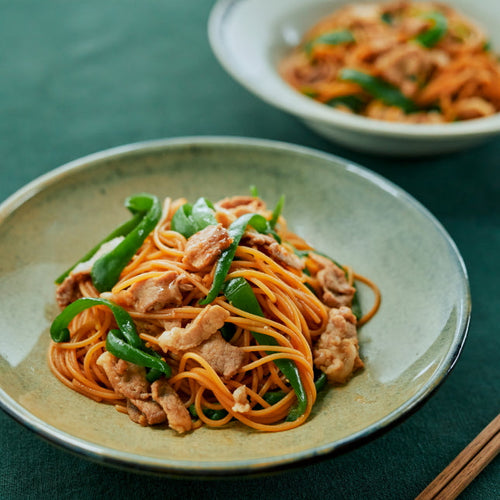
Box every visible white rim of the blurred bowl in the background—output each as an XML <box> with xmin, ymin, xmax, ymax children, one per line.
<box><xmin>207</xmin><ymin>0</ymin><xmax>500</xmax><ymax>140</ymax></box>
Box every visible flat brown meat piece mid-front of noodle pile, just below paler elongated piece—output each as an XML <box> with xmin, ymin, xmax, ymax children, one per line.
<box><xmin>192</xmin><ymin>332</ymin><xmax>245</xmax><ymax>378</ymax></box>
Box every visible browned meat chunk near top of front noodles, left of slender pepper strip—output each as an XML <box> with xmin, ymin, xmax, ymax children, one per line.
<box><xmin>182</xmin><ymin>224</ymin><xmax>233</xmax><ymax>270</ymax></box>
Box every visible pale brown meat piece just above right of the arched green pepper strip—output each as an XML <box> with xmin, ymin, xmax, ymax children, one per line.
<box><xmin>112</xmin><ymin>271</ymin><xmax>184</xmax><ymax>312</ymax></box>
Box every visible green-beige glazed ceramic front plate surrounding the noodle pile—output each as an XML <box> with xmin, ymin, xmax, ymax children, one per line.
<box><xmin>0</xmin><ymin>138</ymin><xmax>470</xmax><ymax>475</ymax></box>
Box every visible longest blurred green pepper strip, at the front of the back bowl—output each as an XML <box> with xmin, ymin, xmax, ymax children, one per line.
<box><xmin>339</xmin><ymin>68</ymin><xmax>418</xmax><ymax>113</ymax></box>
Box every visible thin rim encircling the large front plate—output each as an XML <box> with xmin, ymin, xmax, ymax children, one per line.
<box><xmin>0</xmin><ymin>136</ymin><xmax>471</xmax><ymax>478</ymax></box>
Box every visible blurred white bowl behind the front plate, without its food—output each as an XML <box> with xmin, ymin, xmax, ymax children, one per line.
<box><xmin>208</xmin><ymin>0</ymin><xmax>500</xmax><ymax>156</ymax></box>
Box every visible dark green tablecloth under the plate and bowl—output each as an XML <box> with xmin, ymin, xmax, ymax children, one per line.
<box><xmin>0</xmin><ymin>0</ymin><xmax>500</xmax><ymax>499</ymax></box>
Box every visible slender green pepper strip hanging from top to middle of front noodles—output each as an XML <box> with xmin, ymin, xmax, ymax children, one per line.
<box><xmin>200</xmin><ymin>214</ymin><xmax>270</xmax><ymax>306</ymax></box>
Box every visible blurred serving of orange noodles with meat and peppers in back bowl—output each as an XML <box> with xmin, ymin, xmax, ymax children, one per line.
<box><xmin>279</xmin><ymin>0</ymin><xmax>500</xmax><ymax>123</ymax></box>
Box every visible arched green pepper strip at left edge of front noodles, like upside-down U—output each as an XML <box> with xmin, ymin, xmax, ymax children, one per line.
<box><xmin>50</xmin><ymin>297</ymin><xmax>144</xmax><ymax>349</ymax></box>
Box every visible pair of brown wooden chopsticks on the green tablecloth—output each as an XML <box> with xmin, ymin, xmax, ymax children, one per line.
<box><xmin>415</xmin><ymin>414</ymin><xmax>500</xmax><ymax>500</ymax></box>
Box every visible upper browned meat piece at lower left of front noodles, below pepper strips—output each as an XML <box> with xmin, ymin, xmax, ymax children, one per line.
<box><xmin>97</xmin><ymin>351</ymin><xmax>149</xmax><ymax>399</ymax></box>
